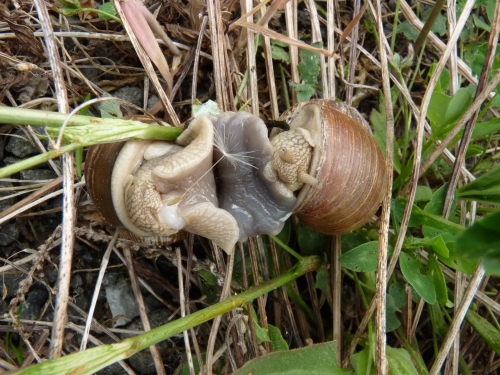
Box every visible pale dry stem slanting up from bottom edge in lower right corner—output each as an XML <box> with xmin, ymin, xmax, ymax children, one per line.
<box><xmin>429</xmin><ymin>263</ymin><xmax>485</xmax><ymax>375</ymax></box>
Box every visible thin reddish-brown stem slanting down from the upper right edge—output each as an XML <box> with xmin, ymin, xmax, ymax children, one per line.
<box><xmin>443</xmin><ymin>1</ymin><xmax>500</xmax><ymax>218</ymax></box>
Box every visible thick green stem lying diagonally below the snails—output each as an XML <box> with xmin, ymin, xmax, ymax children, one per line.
<box><xmin>12</xmin><ymin>256</ymin><xmax>322</xmax><ymax>375</ymax></box>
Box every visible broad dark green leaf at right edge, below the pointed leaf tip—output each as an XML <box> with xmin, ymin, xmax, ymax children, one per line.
<box><xmin>457</xmin><ymin>212</ymin><xmax>500</xmax><ymax>263</ymax></box>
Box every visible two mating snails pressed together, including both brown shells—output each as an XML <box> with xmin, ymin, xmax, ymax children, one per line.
<box><xmin>85</xmin><ymin>100</ymin><xmax>386</xmax><ymax>252</ymax></box>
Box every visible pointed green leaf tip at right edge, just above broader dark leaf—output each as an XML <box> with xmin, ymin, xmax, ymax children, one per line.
<box><xmin>457</xmin><ymin>164</ymin><xmax>500</xmax><ymax>204</ymax></box>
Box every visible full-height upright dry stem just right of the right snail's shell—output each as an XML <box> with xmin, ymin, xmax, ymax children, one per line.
<box><xmin>374</xmin><ymin>0</ymin><xmax>394</xmax><ymax>375</ymax></box>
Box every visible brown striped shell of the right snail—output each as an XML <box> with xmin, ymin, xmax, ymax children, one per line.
<box><xmin>282</xmin><ymin>100</ymin><xmax>386</xmax><ymax>235</ymax></box>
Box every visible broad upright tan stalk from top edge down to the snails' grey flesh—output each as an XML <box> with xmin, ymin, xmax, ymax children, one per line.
<box><xmin>207</xmin><ymin>0</ymin><xmax>233</xmax><ymax>110</ymax></box>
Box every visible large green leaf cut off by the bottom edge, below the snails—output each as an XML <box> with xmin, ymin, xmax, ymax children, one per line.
<box><xmin>233</xmin><ymin>342</ymin><xmax>352</xmax><ymax>375</ymax></box>
